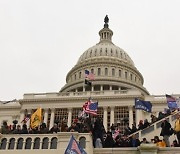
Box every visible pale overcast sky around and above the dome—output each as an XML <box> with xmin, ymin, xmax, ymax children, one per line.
<box><xmin>0</xmin><ymin>0</ymin><xmax>180</xmax><ymax>100</ymax></box>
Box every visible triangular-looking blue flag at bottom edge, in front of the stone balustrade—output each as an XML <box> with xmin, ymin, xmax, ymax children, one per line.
<box><xmin>64</xmin><ymin>135</ymin><xmax>87</xmax><ymax>154</ymax></box>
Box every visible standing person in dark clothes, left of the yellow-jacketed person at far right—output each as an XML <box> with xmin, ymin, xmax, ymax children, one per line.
<box><xmin>160</xmin><ymin>119</ymin><xmax>171</xmax><ymax>147</ymax></box>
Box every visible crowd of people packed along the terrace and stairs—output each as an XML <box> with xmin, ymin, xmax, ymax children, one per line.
<box><xmin>0</xmin><ymin>109</ymin><xmax>180</xmax><ymax>148</ymax></box>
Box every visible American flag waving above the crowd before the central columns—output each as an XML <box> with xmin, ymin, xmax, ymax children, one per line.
<box><xmin>83</xmin><ymin>100</ymin><xmax>98</xmax><ymax>115</ymax></box>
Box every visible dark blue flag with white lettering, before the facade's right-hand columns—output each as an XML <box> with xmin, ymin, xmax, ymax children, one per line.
<box><xmin>135</xmin><ymin>98</ymin><xmax>152</xmax><ymax>112</ymax></box>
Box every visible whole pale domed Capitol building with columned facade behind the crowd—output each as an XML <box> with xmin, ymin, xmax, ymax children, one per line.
<box><xmin>0</xmin><ymin>15</ymin><xmax>180</xmax><ymax>154</ymax></box>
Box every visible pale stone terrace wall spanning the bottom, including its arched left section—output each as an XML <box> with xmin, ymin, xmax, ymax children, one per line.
<box><xmin>0</xmin><ymin>132</ymin><xmax>180</xmax><ymax>154</ymax></box>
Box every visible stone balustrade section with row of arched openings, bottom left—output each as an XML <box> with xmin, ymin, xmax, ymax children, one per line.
<box><xmin>0</xmin><ymin>132</ymin><xmax>93</xmax><ymax>154</ymax></box>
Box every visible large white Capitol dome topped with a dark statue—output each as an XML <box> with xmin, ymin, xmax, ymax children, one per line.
<box><xmin>60</xmin><ymin>15</ymin><xmax>149</xmax><ymax>95</ymax></box>
